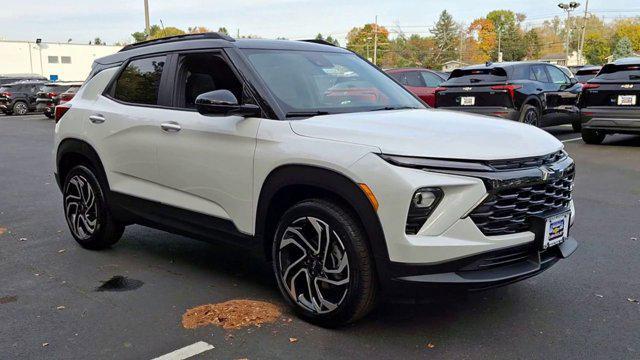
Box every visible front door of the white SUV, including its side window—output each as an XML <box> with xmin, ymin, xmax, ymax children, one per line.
<box><xmin>157</xmin><ymin>51</ymin><xmax>261</xmax><ymax>233</ymax></box>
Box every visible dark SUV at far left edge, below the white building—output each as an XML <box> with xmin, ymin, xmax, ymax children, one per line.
<box><xmin>0</xmin><ymin>81</ymin><xmax>45</xmax><ymax>115</ymax></box>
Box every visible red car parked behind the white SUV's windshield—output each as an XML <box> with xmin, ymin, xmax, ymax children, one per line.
<box><xmin>386</xmin><ymin>68</ymin><xmax>447</xmax><ymax>107</ymax></box>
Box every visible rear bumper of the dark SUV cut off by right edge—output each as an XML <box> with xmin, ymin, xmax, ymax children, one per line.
<box><xmin>580</xmin><ymin>107</ymin><xmax>640</xmax><ymax>134</ymax></box>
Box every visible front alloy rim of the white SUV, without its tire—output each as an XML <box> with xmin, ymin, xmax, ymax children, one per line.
<box><xmin>275</xmin><ymin>217</ymin><xmax>350</xmax><ymax>314</ymax></box>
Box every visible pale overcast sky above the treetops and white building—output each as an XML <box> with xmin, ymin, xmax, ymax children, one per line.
<box><xmin>0</xmin><ymin>0</ymin><xmax>640</xmax><ymax>45</ymax></box>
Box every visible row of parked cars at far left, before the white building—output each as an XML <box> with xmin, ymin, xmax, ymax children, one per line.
<box><xmin>0</xmin><ymin>75</ymin><xmax>82</xmax><ymax>119</ymax></box>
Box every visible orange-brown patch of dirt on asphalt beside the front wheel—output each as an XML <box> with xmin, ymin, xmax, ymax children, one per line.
<box><xmin>182</xmin><ymin>300</ymin><xmax>281</xmax><ymax>329</ymax></box>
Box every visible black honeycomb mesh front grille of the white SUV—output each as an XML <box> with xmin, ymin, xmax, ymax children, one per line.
<box><xmin>469</xmin><ymin>172</ymin><xmax>575</xmax><ymax>236</ymax></box>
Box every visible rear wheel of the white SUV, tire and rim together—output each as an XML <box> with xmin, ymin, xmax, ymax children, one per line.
<box><xmin>62</xmin><ymin>165</ymin><xmax>124</xmax><ymax>250</ymax></box>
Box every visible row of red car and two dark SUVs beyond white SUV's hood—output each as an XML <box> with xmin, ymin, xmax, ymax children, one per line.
<box><xmin>387</xmin><ymin>58</ymin><xmax>640</xmax><ymax>143</ymax></box>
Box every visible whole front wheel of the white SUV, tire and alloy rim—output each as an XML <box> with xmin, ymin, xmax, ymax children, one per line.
<box><xmin>272</xmin><ymin>199</ymin><xmax>377</xmax><ymax>327</ymax></box>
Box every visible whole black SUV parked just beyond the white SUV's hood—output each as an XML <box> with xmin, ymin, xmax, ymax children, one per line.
<box><xmin>436</xmin><ymin>62</ymin><xmax>581</xmax><ymax>127</ymax></box>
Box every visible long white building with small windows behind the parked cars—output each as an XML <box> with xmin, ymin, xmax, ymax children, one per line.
<box><xmin>0</xmin><ymin>40</ymin><xmax>122</xmax><ymax>81</ymax></box>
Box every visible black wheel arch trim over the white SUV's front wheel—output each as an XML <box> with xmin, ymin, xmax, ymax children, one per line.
<box><xmin>255</xmin><ymin>165</ymin><xmax>390</xmax><ymax>278</ymax></box>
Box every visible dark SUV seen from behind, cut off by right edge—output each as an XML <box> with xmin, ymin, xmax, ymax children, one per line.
<box><xmin>578</xmin><ymin>58</ymin><xmax>640</xmax><ymax>144</ymax></box>
